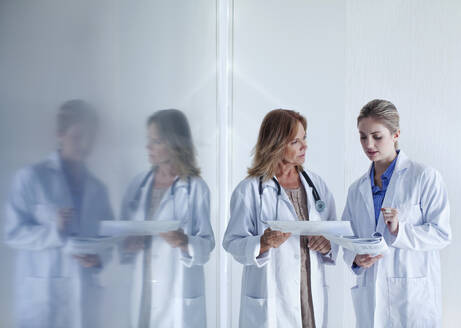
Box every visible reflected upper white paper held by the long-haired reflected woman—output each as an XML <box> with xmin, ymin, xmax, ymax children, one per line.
<box><xmin>99</xmin><ymin>220</ymin><xmax>180</xmax><ymax>236</ymax></box>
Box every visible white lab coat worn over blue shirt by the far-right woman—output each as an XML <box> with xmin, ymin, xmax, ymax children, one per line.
<box><xmin>343</xmin><ymin>151</ymin><xmax>451</xmax><ymax>328</ymax></box>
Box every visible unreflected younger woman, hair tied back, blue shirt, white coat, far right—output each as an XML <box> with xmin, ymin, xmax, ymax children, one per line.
<box><xmin>343</xmin><ymin>99</ymin><xmax>451</xmax><ymax>328</ymax></box>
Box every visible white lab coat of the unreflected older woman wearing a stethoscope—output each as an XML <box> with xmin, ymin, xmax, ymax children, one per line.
<box><xmin>223</xmin><ymin>172</ymin><xmax>337</xmax><ymax>327</ymax></box>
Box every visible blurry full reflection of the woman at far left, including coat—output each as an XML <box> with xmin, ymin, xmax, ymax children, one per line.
<box><xmin>5</xmin><ymin>100</ymin><xmax>112</xmax><ymax>328</ymax></box>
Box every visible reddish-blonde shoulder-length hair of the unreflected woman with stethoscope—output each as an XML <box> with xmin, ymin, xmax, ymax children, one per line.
<box><xmin>248</xmin><ymin>109</ymin><xmax>307</xmax><ymax>180</ymax></box>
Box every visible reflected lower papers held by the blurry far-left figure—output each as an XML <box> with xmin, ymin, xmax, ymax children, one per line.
<box><xmin>64</xmin><ymin>237</ymin><xmax>118</xmax><ymax>255</ymax></box>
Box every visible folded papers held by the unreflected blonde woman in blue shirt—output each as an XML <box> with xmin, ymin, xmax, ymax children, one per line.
<box><xmin>325</xmin><ymin>232</ymin><xmax>388</xmax><ymax>255</ymax></box>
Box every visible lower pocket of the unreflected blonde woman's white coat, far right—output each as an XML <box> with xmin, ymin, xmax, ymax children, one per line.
<box><xmin>388</xmin><ymin>277</ymin><xmax>438</xmax><ymax>328</ymax></box>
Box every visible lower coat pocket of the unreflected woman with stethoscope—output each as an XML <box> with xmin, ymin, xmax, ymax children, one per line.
<box><xmin>240</xmin><ymin>296</ymin><xmax>269</xmax><ymax>328</ymax></box>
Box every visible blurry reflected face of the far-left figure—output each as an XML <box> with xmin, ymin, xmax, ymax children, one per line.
<box><xmin>58</xmin><ymin>123</ymin><xmax>96</xmax><ymax>162</ymax></box>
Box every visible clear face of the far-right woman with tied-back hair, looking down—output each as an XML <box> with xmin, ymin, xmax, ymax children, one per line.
<box><xmin>358</xmin><ymin>117</ymin><xmax>400</xmax><ymax>162</ymax></box>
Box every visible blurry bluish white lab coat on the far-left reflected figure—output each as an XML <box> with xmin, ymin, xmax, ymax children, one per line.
<box><xmin>5</xmin><ymin>153</ymin><xmax>112</xmax><ymax>328</ymax></box>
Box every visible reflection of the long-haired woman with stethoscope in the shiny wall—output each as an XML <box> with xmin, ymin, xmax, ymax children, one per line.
<box><xmin>122</xmin><ymin>109</ymin><xmax>214</xmax><ymax>327</ymax></box>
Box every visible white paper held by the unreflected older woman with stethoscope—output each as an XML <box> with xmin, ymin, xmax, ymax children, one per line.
<box><xmin>266</xmin><ymin>220</ymin><xmax>354</xmax><ymax>236</ymax></box>
